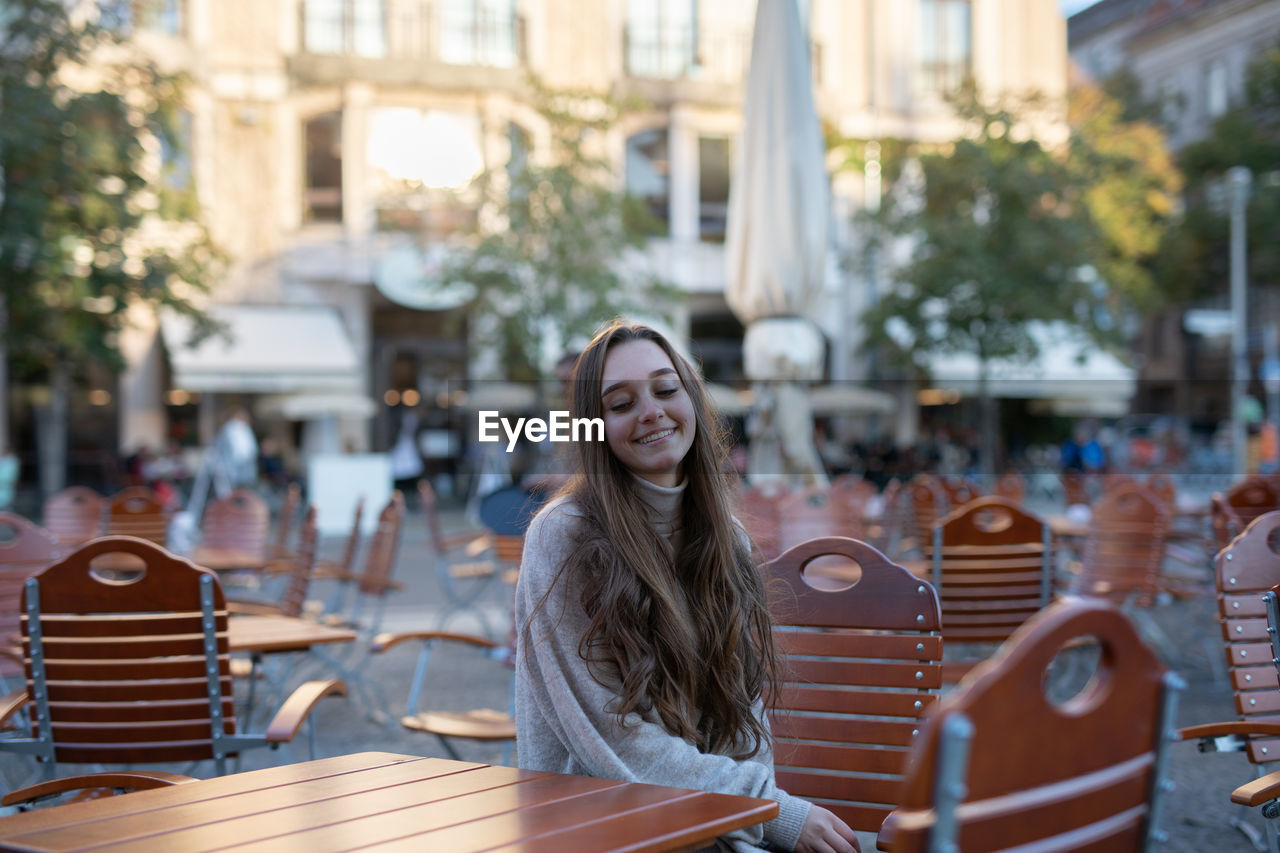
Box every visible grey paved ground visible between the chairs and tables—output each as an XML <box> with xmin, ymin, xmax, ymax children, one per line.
<box><xmin>0</xmin><ymin>489</ymin><xmax>1261</xmax><ymax>853</ymax></box>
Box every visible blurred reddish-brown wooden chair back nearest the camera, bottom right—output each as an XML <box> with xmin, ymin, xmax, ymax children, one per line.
<box><xmin>877</xmin><ymin>599</ymin><xmax>1183</xmax><ymax>853</ymax></box>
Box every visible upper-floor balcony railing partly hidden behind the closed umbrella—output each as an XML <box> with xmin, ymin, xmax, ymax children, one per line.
<box><xmin>622</xmin><ymin>26</ymin><xmax>822</xmax><ymax>86</ymax></box>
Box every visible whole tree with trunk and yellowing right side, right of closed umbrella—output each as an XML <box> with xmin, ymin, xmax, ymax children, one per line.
<box><xmin>864</xmin><ymin>92</ymin><xmax>1167</xmax><ymax>474</ymax></box>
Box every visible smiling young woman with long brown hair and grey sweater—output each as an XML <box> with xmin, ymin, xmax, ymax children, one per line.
<box><xmin>516</xmin><ymin>323</ymin><xmax>859</xmax><ymax>853</ymax></box>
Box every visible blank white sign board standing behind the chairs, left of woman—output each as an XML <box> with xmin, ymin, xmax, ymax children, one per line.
<box><xmin>307</xmin><ymin>453</ymin><xmax>392</xmax><ymax>537</ymax></box>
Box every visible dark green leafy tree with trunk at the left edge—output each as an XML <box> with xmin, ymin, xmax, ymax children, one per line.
<box><xmin>0</xmin><ymin>0</ymin><xmax>219</xmax><ymax>492</ymax></box>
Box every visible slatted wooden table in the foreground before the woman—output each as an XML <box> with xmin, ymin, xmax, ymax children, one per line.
<box><xmin>0</xmin><ymin>752</ymin><xmax>778</xmax><ymax>853</ymax></box>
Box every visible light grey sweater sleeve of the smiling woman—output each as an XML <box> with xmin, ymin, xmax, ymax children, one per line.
<box><xmin>516</xmin><ymin>503</ymin><xmax>810</xmax><ymax>849</ymax></box>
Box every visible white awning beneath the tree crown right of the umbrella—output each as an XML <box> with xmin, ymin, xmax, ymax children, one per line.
<box><xmin>928</xmin><ymin>323</ymin><xmax>1137</xmax><ymax>403</ymax></box>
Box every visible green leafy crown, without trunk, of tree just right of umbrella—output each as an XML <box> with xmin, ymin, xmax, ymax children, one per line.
<box><xmin>865</xmin><ymin>93</ymin><xmax>1108</xmax><ymax>368</ymax></box>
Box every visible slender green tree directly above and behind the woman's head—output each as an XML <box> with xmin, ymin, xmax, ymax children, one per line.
<box><xmin>442</xmin><ymin>81</ymin><xmax>678</xmax><ymax>379</ymax></box>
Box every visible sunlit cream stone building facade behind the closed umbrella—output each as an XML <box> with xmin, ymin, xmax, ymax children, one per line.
<box><xmin>120</xmin><ymin>0</ymin><xmax>1066</xmax><ymax>479</ymax></box>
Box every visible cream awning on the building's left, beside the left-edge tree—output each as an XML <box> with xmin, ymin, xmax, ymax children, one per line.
<box><xmin>160</xmin><ymin>305</ymin><xmax>361</xmax><ymax>393</ymax></box>
